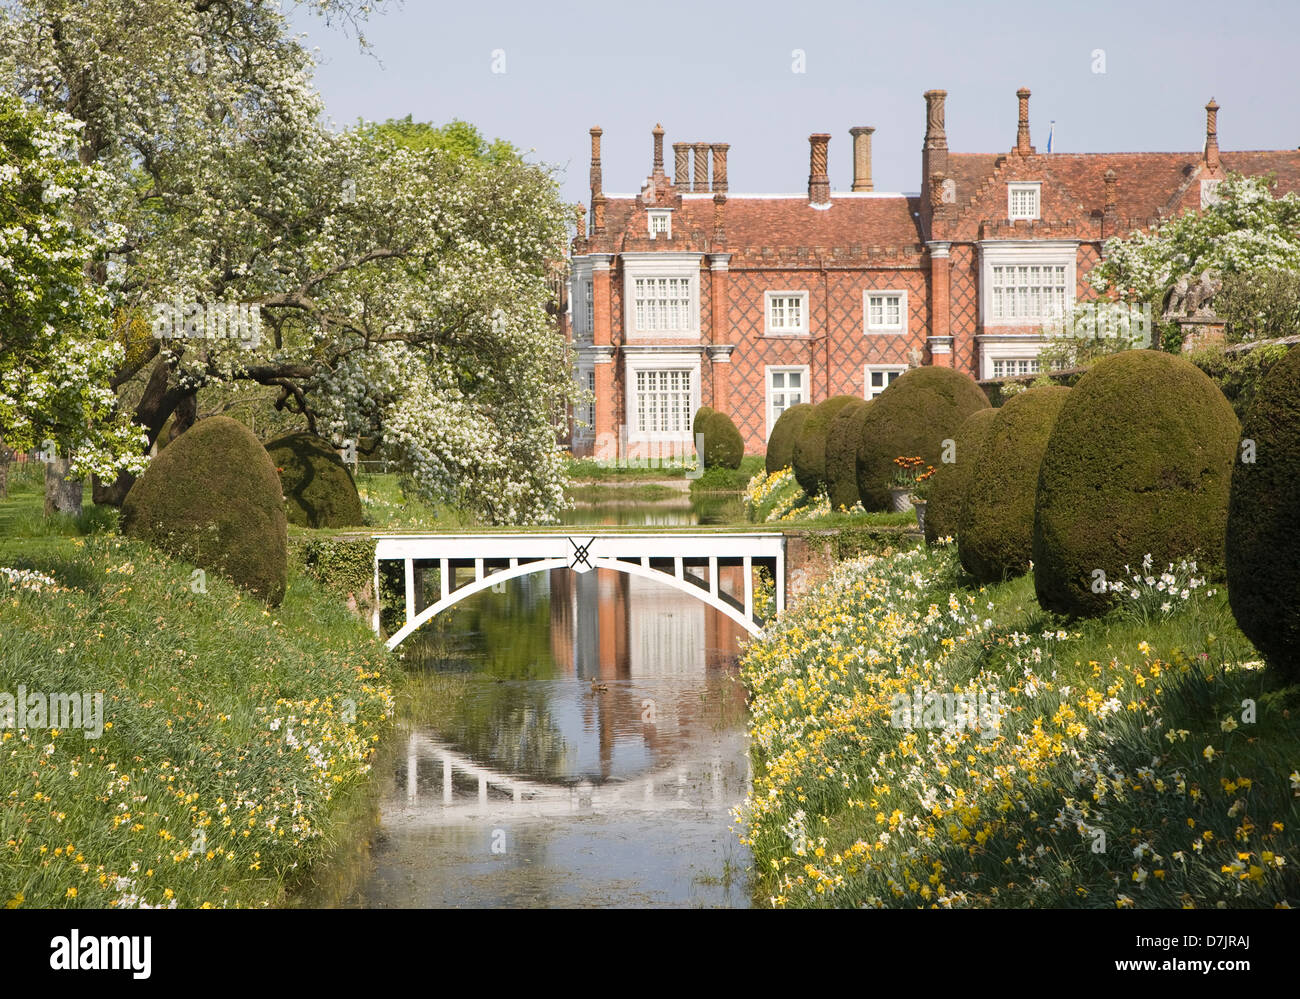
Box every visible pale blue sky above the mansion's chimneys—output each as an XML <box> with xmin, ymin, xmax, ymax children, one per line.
<box><xmin>294</xmin><ymin>0</ymin><xmax>1300</xmax><ymax>202</ymax></box>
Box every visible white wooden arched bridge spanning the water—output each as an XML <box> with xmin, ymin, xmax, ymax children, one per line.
<box><xmin>373</xmin><ymin>529</ymin><xmax>785</xmax><ymax>649</ymax></box>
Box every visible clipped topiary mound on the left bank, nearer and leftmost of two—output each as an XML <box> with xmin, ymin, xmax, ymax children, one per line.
<box><xmin>121</xmin><ymin>416</ymin><xmax>289</xmax><ymax>605</ymax></box>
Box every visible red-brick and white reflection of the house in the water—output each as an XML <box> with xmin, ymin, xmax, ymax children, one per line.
<box><xmin>550</xmin><ymin>567</ymin><xmax>745</xmax><ymax>778</ymax></box>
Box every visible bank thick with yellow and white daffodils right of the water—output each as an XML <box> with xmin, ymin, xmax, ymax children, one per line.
<box><xmin>738</xmin><ymin>546</ymin><xmax>1300</xmax><ymax>908</ymax></box>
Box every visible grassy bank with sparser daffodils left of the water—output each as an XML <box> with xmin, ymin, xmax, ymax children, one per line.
<box><xmin>0</xmin><ymin>465</ymin><xmax>399</xmax><ymax>908</ymax></box>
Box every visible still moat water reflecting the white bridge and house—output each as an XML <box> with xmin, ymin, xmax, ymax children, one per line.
<box><xmin>350</xmin><ymin>507</ymin><xmax>750</xmax><ymax>908</ymax></box>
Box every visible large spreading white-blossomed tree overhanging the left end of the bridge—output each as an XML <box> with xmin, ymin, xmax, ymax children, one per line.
<box><xmin>0</xmin><ymin>0</ymin><xmax>576</xmax><ymax>522</ymax></box>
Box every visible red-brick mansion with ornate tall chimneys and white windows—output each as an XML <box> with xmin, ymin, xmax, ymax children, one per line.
<box><xmin>564</xmin><ymin>88</ymin><xmax>1300</xmax><ymax>459</ymax></box>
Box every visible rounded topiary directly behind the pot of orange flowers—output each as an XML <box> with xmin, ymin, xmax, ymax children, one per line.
<box><xmin>858</xmin><ymin>367</ymin><xmax>989</xmax><ymax>510</ymax></box>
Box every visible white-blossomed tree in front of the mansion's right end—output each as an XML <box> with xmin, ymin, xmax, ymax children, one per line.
<box><xmin>1088</xmin><ymin>174</ymin><xmax>1300</xmax><ymax>351</ymax></box>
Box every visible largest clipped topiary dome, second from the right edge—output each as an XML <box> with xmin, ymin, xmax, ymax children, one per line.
<box><xmin>1034</xmin><ymin>350</ymin><xmax>1239</xmax><ymax>615</ymax></box>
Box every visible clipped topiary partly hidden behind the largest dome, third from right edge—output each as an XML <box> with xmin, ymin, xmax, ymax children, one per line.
<box><xmin>961</xmin><ymin>385</ymin><xmax>1070</xmax><ymax>583</ymax></box>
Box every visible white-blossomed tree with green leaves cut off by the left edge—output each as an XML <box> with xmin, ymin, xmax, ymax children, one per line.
<box><xmin>0</xmin><ymin>95</ymin><xmax>144</xmax><ymax>506</ymax></box>
